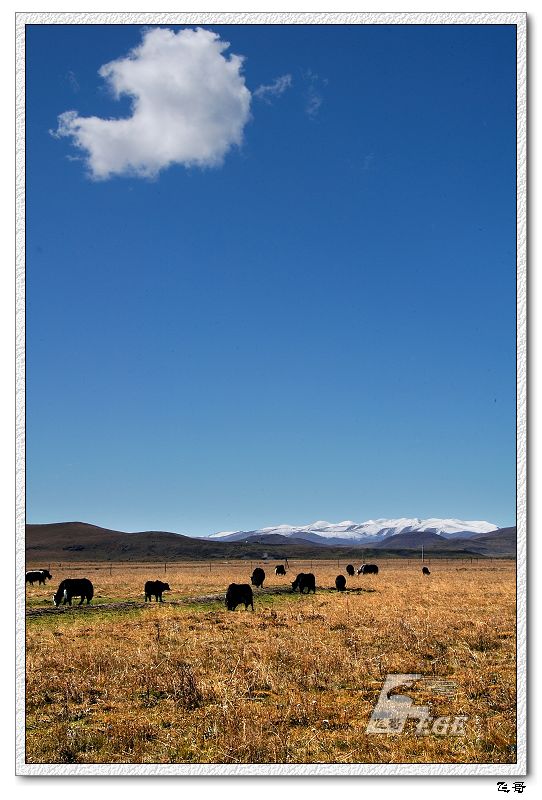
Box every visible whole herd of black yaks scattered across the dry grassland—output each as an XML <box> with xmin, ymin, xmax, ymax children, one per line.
<box><xmin>26</xmin><ymin>564</ymin><xmax>431</xmax><ymax>611</ymax></box>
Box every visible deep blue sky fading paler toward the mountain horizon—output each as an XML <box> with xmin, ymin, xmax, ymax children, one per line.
<box><xmin>26</xmin><ymin>25</ymin><xmax>516</xmax><ymax>535</ymax></box>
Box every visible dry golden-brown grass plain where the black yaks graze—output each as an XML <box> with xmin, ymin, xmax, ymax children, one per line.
<box><xmin>26</xmin><ymin>561</ymin><xmax>516</xmax><ymax>764</ymax></box>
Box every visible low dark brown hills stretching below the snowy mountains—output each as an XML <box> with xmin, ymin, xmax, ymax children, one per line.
<box><xmin>26</xmin><ymin>522</ymin><xmax>516</xmax><ymax>564</ymax></box>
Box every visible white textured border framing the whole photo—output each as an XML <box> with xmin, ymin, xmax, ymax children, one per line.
<box><xmin>15</xmin><ymin>12</ymin><xmax>527</xmax><ymax>777</ymax></box>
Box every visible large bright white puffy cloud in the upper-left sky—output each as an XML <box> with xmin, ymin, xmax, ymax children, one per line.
<box><xmin>55</xmin><ymin>28</ymin><xmax>251</xmax><ymax>180</ymax></box>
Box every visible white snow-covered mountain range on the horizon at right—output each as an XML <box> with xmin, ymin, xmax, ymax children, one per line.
<box><xmin>208</xmin><ymin>518</ymin><xmax>498</xmax><ymax>545</ymax></box>
